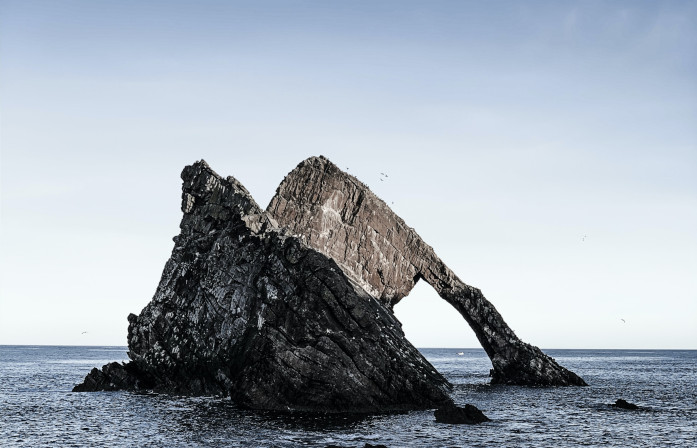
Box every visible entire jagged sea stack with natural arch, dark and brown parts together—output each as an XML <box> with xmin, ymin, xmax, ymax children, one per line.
<box><xmin>74</xmin><ymin>157</ymin><xmax>585</xmax><ymax>412</ymax></box>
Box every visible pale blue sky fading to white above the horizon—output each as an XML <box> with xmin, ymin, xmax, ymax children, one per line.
<box><xmin>0</xmin><ymin>0</ymin><xmax>697</xmax><ymax>349</ymax></box>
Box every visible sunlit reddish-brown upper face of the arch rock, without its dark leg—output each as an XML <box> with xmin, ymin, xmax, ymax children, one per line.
<box><xmin>266</xmin><ymin>156</ymin><xmax>422</xmax><ymax>308</ymax></box>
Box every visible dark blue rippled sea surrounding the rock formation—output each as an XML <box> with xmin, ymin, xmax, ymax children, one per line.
<box><xmin>0</xmin><ymin>346</ymin><xmax>697</xmax><ymax>448</ymax></box>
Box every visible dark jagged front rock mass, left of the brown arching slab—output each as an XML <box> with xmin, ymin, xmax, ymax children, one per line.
<box><xmin>75</xmin><ymin>161</ymin><xmax>450</xmax><ymax>412</ymax></box>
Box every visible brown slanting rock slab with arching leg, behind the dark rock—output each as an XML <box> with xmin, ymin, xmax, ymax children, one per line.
<box><xmin>267</xmin><ymin>157</ymin><xmax>586</xmax><ymax>386</ymax></box>
